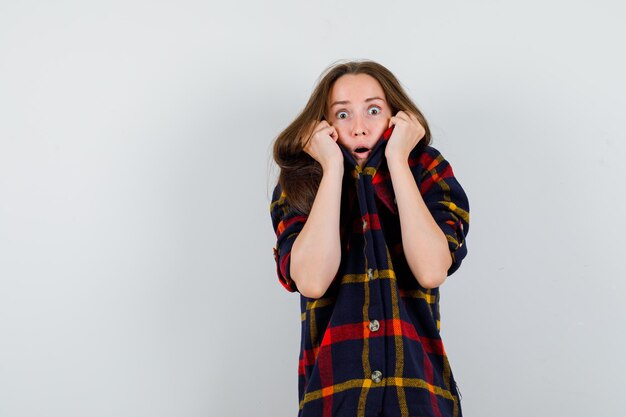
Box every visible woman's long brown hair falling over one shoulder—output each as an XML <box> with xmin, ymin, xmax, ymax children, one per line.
<box><xmin>273</xmin><ymin>61</ymin><xmax>431</xmax><ymax>214</ymax></box>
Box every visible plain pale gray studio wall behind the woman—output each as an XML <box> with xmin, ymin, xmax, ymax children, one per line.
<box><xmin>0</xmin><ymin>0</ymin><xmax>626</xmax><ymax>417</ymax></box>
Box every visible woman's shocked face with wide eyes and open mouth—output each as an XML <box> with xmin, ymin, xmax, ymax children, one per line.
<box><xmin>327</xmin><ymin>74</ymin><xmax>392</xmax><ymax>167</ymax></box>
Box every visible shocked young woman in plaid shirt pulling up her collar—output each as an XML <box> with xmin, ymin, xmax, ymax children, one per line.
<box><xmin>270</xmin><ymin>61</ymin><xmax>469</xmax><ymax>417</ymax></box>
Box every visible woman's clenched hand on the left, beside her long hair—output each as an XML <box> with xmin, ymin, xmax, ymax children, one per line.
<box><xmin>304</xmin><ymin>120</ymin><xmax>343</xmax><ymax>171</ymax></box>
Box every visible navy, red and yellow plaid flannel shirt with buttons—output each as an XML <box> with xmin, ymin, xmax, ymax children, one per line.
<box><xmin>270</xmin><ymin>129</ymin><xmax>469</xmax><ymax>417</ymax></box>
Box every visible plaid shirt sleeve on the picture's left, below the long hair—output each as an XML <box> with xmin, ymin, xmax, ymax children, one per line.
<box><xmin>270</xmin><ymin>184</ymin><xmax>308</xmax><ymax>292</ymax></box>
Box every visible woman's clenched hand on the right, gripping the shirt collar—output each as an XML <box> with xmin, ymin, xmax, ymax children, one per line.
<box><xmin>385</xmin><ymin>110</ymin><xmax>426</xmax><ymax>162</ymax></box>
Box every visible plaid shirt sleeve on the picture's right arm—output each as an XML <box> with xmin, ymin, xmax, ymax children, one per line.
<box><xmin>416</xmin><ymin>146</ymin><xmax>469</xmax><ymax>276</ymax></box>
